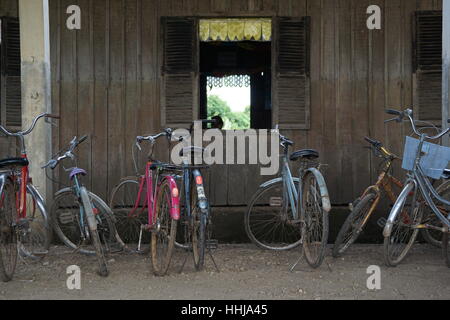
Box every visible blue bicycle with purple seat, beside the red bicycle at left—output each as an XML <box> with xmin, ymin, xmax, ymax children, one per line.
<box><xmin>42</xmin><ymin>136</ymin><xmax>123</xmax><ymax>277</ymax></box>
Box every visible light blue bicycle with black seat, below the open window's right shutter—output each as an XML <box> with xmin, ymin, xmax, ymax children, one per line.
<box><xmin>245</xmin><ymin>129</ymin><xmax>331</xmax><ymax>268</ymax></box>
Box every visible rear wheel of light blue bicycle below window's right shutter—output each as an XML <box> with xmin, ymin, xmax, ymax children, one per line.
<box><xmin>299</xmin><ymin>172</ymin><xmax>328</xmax><ymax>268</ymax></box>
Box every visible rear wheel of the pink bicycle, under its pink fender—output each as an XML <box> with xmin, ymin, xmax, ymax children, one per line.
<box><xmin>151</xmin><ymin>182</ymin><xmax>177</xmax><ymax>276</ymax></box>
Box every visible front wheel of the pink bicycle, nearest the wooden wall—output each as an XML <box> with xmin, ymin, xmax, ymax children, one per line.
<box><xmin>110</xmin><ymin>178</ymin><xmax>151</xmax><ymax>253</ymax></box>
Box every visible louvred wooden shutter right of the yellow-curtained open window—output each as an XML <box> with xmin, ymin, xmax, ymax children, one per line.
<box><xmin>273</xmin><ymin>17</ymin><xmax>310</xmax><ymax>130</ymax></box>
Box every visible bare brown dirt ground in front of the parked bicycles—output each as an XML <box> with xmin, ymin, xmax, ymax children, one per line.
<box><xmin>0</xmin><ymin>245</ymin><xmax>450</xmax><ymax>300</ymax></box>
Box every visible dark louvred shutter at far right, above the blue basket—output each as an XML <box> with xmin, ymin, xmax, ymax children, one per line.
<box><xmin>414</xmin><ymin>11</ymin><xmax>442</xmax><ymax>122</ymax></box>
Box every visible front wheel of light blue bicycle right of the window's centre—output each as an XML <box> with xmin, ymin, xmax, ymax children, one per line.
<box><xmin>244</xmin><ymin>181</ymin><xmax>301</xmax><ymax>251</ymax></box>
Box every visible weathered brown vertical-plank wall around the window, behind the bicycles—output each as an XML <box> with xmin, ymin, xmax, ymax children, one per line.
<box><xmin>48</xmin><ymin>0</ymin><xmax>442</xmax><ymax>205</ymax></box>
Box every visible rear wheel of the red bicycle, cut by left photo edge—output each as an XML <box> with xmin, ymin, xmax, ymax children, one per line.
<box><xmin>0</xmin><ymin>180</ymin><xmax>18</xmax><ymax>282</ymax></box>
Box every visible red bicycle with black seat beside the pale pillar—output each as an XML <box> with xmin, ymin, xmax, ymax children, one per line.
<box><xmin>0</xmin><ymin>113</ymin><xmax>59</xmax><ymax>282</ymax></box>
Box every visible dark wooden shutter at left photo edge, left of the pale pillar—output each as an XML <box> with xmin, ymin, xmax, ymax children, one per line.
<box><xmin>0</xmin><ymin>18</ymin><xmax>22</xmax><ymax>130</ymax></box>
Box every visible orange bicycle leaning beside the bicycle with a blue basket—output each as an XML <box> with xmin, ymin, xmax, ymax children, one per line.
<box><xmin>332</xmin><ymin>137</ymin><xmax>404</xmax><ymax>258</ymax></box>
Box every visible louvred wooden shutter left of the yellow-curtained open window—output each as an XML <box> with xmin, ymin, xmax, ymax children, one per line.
<box><xmin>161</xmin><ymin>18</ymin><xmax>199</xmax><ymax>127</ymax></box>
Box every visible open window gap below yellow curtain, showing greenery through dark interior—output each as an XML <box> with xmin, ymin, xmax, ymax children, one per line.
<box><xmin>200</xmin><ymin>41</ymin><xmax>272</xmax><ymax>130</ymax></box>
